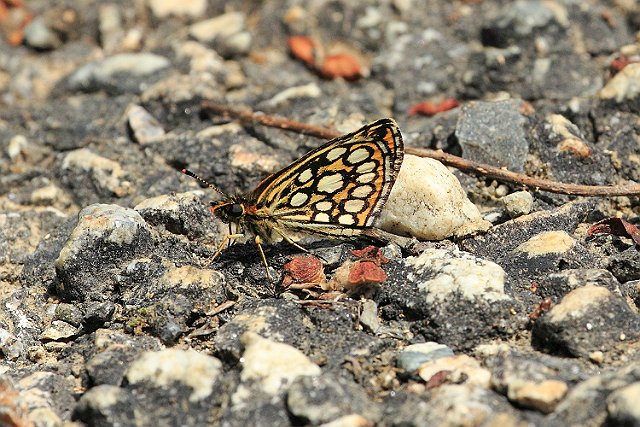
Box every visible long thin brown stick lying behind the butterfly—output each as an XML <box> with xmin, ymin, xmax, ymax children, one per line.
<box><xmin>202</xmin><ymin>101</ymin><xmax>640</xmax><ymax>197</ymax></box>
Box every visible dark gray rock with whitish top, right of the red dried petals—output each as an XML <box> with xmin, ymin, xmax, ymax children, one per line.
<box><xmin>376</xmin><ymin>249</ymin><xmax>523</xmax><ymax>350</ymax></box>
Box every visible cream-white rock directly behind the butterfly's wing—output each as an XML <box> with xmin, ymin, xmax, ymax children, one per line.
<box><xmin>375</xmin><ymin>155</ymin><xmax>491</xmax><ymax>240</ymax></box>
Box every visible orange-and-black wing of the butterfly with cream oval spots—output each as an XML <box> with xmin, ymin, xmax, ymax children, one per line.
<box><xmin>248</xmin><ymin>119</ymin><xmax>404</xmax><ymax>236</ymax></box>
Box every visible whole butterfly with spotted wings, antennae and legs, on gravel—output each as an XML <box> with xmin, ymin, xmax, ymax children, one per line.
<box><xmin>182</xmin><ymin>119</ymin><xmax>404</xmax><ymax>279</ymax></box>
